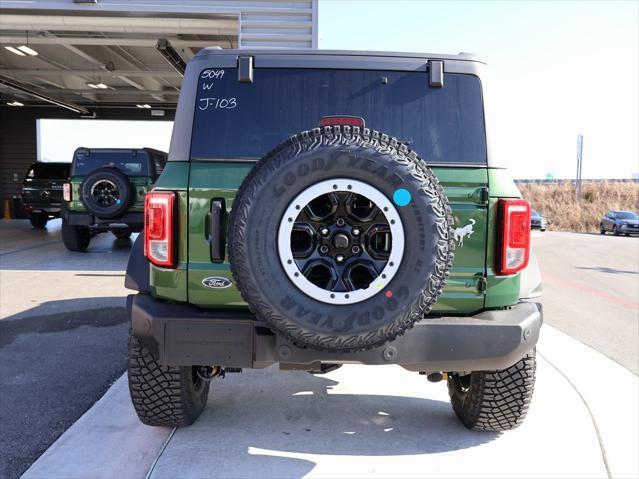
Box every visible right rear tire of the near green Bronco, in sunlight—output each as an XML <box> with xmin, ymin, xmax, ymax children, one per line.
<box><xmin>448</xmin><ymin>349</ymin><xmax>536</xmax><ymax>431</ymax></box>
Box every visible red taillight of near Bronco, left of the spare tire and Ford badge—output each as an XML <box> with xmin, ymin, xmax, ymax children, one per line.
<box><xmin>144</xmin><ymin>191</ymin><xmax>175</xmax><ymax>268</ymax></box>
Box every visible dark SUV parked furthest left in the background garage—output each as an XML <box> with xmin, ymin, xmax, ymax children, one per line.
<box><xmin>21</xmin><ymin>162</ymin><xmax>71</xmax><ymax>228</ymax></box>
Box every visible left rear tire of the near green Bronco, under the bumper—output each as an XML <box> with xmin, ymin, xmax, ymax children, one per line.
<box><xmin>128</xmin><ymin>334</ymin><xmax>210</xmax><ymax>427</ymax></box>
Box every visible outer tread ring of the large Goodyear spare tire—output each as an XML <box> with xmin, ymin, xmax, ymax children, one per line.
<box><xmin>229</xmin><ymin>125</ymin><xmax>455</xmax><ymax>352</ymax></box>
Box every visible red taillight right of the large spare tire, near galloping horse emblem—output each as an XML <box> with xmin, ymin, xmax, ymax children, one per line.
<box><xmin>497</xmin><ymin>199</ymin><xmax>530</xmax><ymax>275</ymax></box>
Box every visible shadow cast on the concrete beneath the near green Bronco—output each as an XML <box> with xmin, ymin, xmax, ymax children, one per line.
<box><xmin>151</xmin><ymin>366</ymin><xmax>499</xmax><ymax>478</ymax></box>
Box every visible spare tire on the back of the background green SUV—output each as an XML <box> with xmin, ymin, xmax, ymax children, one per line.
<box><xmin>80</xmin><ymin>168</ymin><xmax>133</xmax><ymax>219</ymax></box>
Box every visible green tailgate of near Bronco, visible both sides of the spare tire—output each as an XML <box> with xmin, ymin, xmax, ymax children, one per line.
<box><xmin>188</xmin><ymin>161</ymin><xmax>488</xmax><ymax>314</ymax></box>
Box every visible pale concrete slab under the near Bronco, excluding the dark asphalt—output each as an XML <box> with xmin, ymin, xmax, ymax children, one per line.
<box><xmin>24</xmin><ymin>327</ymin><xmax>639</xmax><ymax>479</ymax></box>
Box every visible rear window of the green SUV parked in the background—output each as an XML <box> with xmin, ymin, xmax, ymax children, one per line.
<box><xmin>73</xmin><ymin>150</ymin><xmax>148</xmax><ymax>176</ymax></box>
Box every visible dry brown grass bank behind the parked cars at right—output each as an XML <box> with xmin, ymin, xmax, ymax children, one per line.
<box><xmin>518</xmin><ymin>181</ymin><xmax>639</xmax><ymax>233</ymax></box>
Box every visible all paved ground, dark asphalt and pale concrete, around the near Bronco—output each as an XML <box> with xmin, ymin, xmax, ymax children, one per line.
<box><xmin>5</xmin><ymin>226</ymin><xmax>639</xmax><ymax>479</ymax></box>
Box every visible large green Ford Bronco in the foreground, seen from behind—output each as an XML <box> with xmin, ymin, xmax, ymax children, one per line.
<box><xmin>126</xmin><ymin>49</ymin><xmax>542</xmax><ymax>431</ymax></box>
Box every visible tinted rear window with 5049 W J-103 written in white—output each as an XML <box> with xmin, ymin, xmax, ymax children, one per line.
<box><xmin>191</xmin><ymin>68</ymin><xmax>486</xmax><ymax>164</ymax></box>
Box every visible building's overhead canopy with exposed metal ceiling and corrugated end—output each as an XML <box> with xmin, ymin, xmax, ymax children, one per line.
<box><xmin>0</xmin><ymin>0</ymin><xmax>317</xmax><ymax>115</ymax></box>
